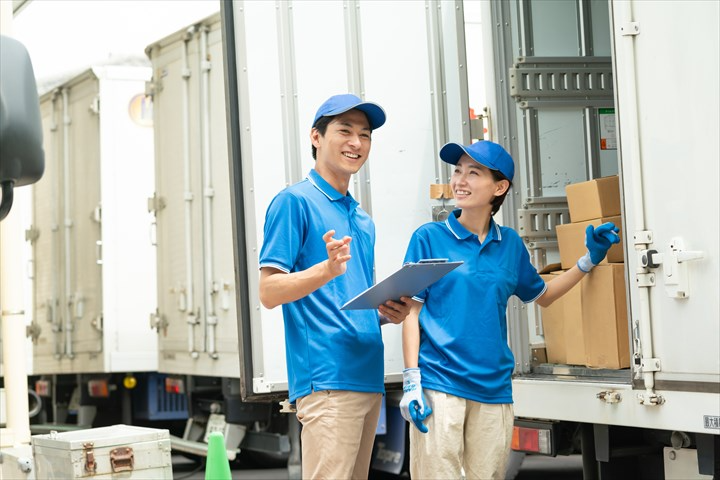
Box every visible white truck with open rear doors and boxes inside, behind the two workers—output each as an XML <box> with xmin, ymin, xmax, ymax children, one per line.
<box><xmin>223</xmin><ymin>0</ymin><xmax>720</xmax><ymax>478</ymax></box>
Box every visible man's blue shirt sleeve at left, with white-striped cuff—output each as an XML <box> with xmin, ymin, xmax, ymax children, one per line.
<box><xmin>259</xmin><ymin>190</ymin><xmax>308</xmax><ymax>273</ymax></box>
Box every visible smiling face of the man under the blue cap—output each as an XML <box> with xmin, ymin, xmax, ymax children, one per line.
<box><xmin>310</xmin><ymin>110</ymin><xmax>371</xmax><ymax>178</ymax></box>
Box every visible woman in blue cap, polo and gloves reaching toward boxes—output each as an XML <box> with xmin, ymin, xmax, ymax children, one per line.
<box><xmin>400</xmin><ymin>141</ymin><xmax>619</xmax><ymax>479</ymax></box>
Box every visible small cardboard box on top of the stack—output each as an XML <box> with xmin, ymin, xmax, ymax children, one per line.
<box><xmin>565</xmin><ymin>175</ymin><xmax>620</xmax><ymax>223</ymax></box>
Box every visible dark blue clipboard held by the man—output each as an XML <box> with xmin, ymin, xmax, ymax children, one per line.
<box><xmin>341</xmin><ymin>258</ymin><xmax>463</xmax><ymax>310</ymax></box>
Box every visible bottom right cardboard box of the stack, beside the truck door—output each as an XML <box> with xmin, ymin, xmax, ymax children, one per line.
<box><xmin>580</xmin><ymin>264</ymin><xmax>630</xmax><ymax>369</ymax></box>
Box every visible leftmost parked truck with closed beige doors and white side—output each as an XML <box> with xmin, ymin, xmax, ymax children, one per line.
<box><xmin>26</xmin><ymin>65</ymin><xmax>162</xmax><ymax>425</ymax></box>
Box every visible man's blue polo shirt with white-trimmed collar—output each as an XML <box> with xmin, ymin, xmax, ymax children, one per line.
<box><xmin>259</xmin><ymin>169</ymin><xmax>384</xmax><ymax>402</ymax></box>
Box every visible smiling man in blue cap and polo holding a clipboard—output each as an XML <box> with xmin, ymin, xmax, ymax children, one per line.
<box><xmin>260</xmin><ymin>94</ymin><xmax>410</xmax><ymax>479</ymax></box>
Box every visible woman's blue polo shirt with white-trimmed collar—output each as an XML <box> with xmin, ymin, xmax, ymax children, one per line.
<box><xmin>405</xmin><ymin>210</ymin><xmax>547</xmax><ymax>403</ymax></box>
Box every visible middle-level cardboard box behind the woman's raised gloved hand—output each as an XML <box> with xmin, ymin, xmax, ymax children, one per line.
<box><xmin>555</xmin><ymin>216</ymin><xmax>625</xmax><ymax>270</ymax></box>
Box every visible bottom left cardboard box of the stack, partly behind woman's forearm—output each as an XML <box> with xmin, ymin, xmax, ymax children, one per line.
<box><xmin>540</xmin><ymin>271</ymin><xmax>586</xmax><ymax>365</ymax></box>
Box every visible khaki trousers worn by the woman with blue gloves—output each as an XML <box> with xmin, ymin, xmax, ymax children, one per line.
<box><xmin>410</xmin><ymin>390</ymin><xmax>514</xmax><ymax>480</ymax></box>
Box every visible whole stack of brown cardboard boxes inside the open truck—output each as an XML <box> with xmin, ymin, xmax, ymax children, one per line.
<box><xmin>542</xmin><ymin>176</ymin><xmax>630</xmax><ymax>369</ymax></box>
